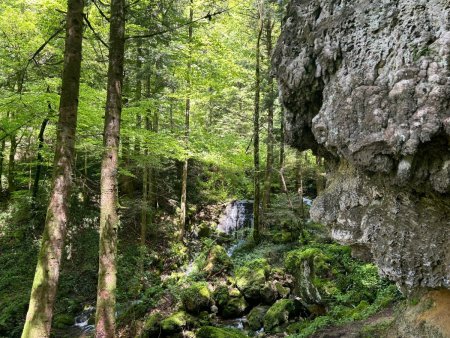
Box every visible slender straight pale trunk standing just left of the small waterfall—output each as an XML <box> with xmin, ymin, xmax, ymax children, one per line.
<box><xmin>180</xmin><ymin>0</ymin><xmax>194</xmax><ymax>240</ymax></box>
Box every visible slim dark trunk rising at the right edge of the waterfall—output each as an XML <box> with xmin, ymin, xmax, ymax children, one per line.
<box><xmin>253</xmin><ymin>13</ymin><xmax>264</xmax><ymax>243</ymax></box>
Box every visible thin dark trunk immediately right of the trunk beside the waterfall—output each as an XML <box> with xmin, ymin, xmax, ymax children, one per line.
<box><xmin>262</xmin><ymin>14</ymin><xmax>275</xmax><ymax>215</ymax></box>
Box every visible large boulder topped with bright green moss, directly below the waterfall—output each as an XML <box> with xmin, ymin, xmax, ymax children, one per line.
<box><xmin>235</xmin><ymin>258</ymin><xmax>270</xmax><ymax>301</ymax></box>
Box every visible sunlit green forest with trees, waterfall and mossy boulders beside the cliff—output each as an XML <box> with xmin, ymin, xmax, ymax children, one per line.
<box><xmin>0</xmin><ymin>0</ymin><xmax>403</xmax><ymax>338</ymax></box>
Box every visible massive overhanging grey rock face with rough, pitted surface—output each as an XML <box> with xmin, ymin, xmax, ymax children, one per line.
<box><xmin>273</xmin><ymin>0</ymin><xmax>450</xmax><ymax>290</ymax></box>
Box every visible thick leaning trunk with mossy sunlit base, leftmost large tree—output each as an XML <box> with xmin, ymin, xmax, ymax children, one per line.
<box><xmin>22</xmin><ymin>0</ymin><xmax>84</xmax><ymax>338</ymax></box>
